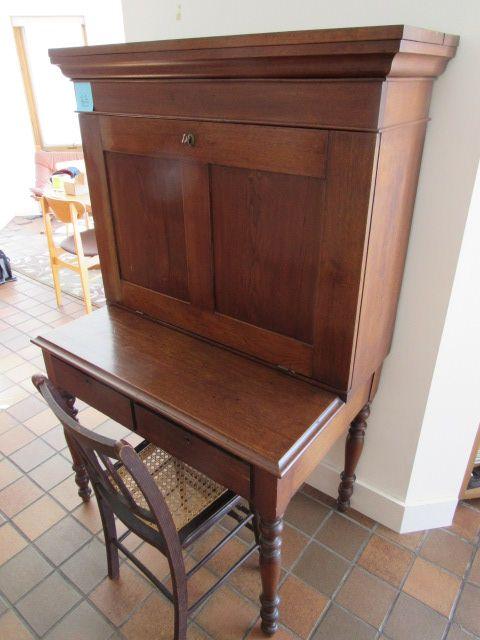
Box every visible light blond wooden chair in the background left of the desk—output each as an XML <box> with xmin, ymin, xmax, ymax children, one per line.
<box><xmin>41</xmin><ymin>196</ymin><xmax>100</xmax><ymax>313</ymax></box>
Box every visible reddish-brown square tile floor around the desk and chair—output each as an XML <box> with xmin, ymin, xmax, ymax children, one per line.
<box><xmin>0</xmin><ymin>277</ymin><xmax>480</xmax><ymax>640</ymax></box>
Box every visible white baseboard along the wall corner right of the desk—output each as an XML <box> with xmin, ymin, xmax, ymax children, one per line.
<box><xmin>308</xmin><ymin>462</ymin><xmax>457</xmax><ymax>533</ymax></box>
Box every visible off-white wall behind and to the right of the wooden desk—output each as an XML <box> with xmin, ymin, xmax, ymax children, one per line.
<box><xmin>123</xmin><ymin>0</ymin><xmax>480</xmax><ymax>529</ymax></box>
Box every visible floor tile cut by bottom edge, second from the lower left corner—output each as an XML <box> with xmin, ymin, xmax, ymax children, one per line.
<box><xmin>45</xmin><ymin>602</ymin><xmax>112</xmax><ymax>640</ymax></box>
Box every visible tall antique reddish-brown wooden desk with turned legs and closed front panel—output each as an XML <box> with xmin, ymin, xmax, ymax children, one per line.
<box><xmin>35</xmin><ymin>26</ymin><xmax>458</xmax><ymax>634</ymax></box>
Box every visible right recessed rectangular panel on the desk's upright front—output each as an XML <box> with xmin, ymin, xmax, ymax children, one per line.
<box><xmin>210</xmin><ymin>166</ymin><xmax>324</xmax><ymax>344</ymax></box>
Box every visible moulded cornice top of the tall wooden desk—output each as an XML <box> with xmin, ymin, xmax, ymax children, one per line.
<box><xmin>50</xmin><ymin>25</ymin><xmax>459</xmax><ymax>79</ymax></box>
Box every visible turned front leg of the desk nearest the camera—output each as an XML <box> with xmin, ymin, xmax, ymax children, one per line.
<box><xmin>259</xmin><ymin>518</ymin><xmax>283</xmax><ymax>636</ymax></box>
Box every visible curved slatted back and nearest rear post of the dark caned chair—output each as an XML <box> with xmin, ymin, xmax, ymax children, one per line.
<box><xmin>32</xmin><ymin>374</ymin><xmax>188</xmax><ymax>640</ymax></box>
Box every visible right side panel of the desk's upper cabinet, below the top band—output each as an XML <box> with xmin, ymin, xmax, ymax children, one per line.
<box><xmin>352</xmin><ymin>122</ymin><xmax>426</xmax><ymax>387</ymax></box>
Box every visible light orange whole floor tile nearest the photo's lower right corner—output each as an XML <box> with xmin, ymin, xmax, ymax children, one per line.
<box><xmin>403</xmin><ymin>558</ymin><xmax>460</xmax><ymax>617</ymax></box>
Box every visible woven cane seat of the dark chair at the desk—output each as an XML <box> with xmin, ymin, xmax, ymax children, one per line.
<box><xmin>116</xmin><ymin>443</ymin><xmax>227</xmax><ymax>531</ymax></box>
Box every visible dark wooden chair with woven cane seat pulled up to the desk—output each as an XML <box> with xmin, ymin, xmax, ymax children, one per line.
<box><xmin>32</xmin><ymin>374</ymin><xmax>259</xmax><ymax>640</ymax></box>
